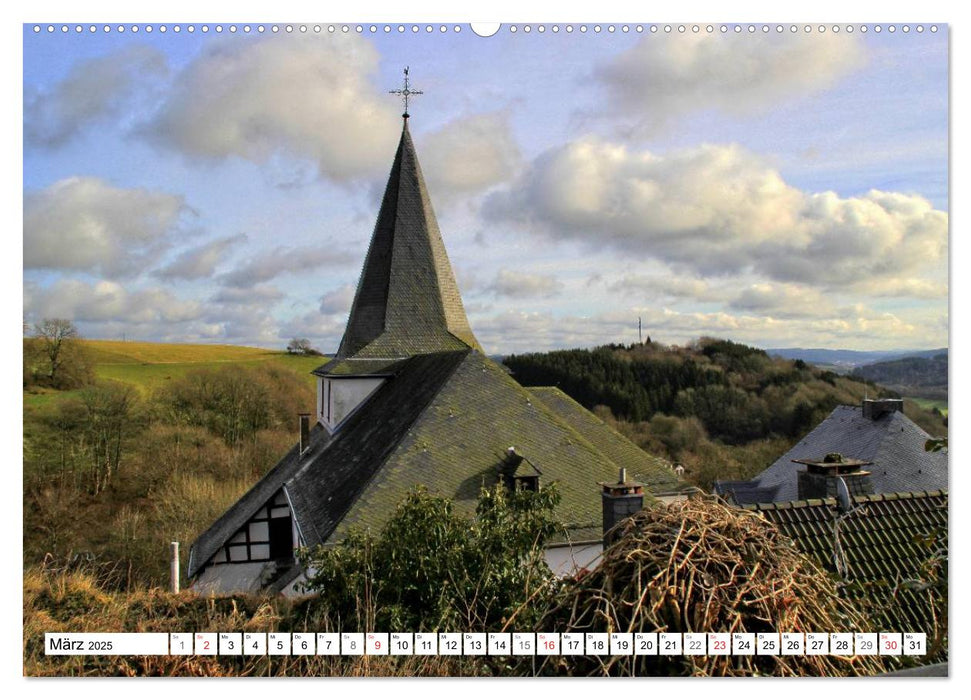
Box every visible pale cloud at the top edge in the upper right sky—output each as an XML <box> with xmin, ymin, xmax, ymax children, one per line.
<box><xmin>595</xmin><ymin>32</ymin><xmax>865</xmax><ymax>133</ymax></box>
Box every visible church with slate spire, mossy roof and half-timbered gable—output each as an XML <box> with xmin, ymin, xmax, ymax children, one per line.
<box><xmin>188</xmin><ymin>105</ymin><xmax>683</xmax><ymax>595</ymax></box>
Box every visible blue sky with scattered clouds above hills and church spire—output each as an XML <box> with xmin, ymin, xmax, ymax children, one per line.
<box><xmin>23</xmin><ymin>23</ymin><xmax>949</xmax><ymax>353</ymax></box>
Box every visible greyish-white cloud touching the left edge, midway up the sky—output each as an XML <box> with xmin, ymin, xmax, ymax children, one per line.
<box><xmin>24</xmin><ymin>177</ymin><xmax>190</xmax><ymax>276</ymax></box>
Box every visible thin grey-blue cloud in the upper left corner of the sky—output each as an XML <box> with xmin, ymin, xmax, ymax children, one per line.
<box><xmin>24</xmin><ymin>44</ymin><xmax>167</xmax><ymax>148</ymax></box>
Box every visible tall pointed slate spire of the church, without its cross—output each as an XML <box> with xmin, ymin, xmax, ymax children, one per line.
<box><xmin>335</xmin><ymin>119</ymin><xmax>482</xmax><ymax>360</ymax></box>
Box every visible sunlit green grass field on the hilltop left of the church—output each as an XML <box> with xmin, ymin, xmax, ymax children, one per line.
<box><xmin>24</xmin><ymin>340</ymin><xmax>327</xmax><ymax>408</ymax></box>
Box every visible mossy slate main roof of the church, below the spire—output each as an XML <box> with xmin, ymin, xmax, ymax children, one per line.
<box><xmin>188</xmin><ymin>350</ymin><xmax>680</xmax><ymax>576</ymax></box>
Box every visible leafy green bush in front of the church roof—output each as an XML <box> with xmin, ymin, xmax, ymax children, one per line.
<box><xmin>302</xmin><ymin>485</ymin><xmax>559</xmax><ymax>631</ymax></box>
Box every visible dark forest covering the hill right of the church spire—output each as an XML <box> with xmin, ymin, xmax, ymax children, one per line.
<box><xmin>504</xmin><ymin>338</ymin><xmax>947</xmax><ymax>488</ymax></box>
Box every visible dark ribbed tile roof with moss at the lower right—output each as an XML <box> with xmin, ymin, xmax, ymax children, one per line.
<box><xmin>746</xmin><ymin>490</ymin><xmax>948</xmax><ymax>636</ymax></box>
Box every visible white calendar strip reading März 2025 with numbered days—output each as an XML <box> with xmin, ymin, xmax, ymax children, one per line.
<box><xmin>44</xmin><ymin>632</ymin><xmax>927</xmax><ymax>657</ymax></box>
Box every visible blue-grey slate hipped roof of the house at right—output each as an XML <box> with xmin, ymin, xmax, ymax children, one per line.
<box><xmin>715</xmin><ymin>406</ymin><xmax>947</xmax><ymax>504</ymax></box>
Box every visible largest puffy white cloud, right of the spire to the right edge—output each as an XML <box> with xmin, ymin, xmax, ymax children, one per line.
<box><xmin>485</xmin><ymin>139</ymin><xmax>948</xmax><ymax>296</ymax></box>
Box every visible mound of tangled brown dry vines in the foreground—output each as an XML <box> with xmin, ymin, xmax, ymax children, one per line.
<box><xmin>537</xmin><ymin>498</ymin><xmax>885</xmax><ymax>676</ymax></box>
